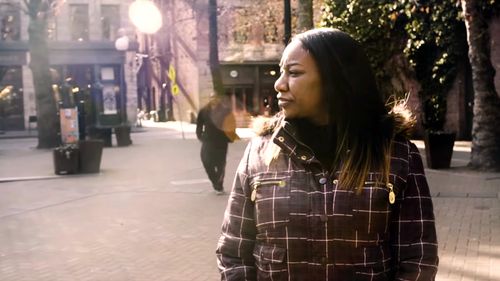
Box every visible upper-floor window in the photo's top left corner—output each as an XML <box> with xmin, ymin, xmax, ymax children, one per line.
<box><xmin>0</xmin><ymin>4</ymin><xmax>21</xmax><ymax>41</ymax></box>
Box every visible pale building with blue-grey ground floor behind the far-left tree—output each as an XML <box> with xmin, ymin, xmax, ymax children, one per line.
<box><xmin>0</xmin><ymin>0</ymin><xmax>137</xmax><ymax>130</ymax></box>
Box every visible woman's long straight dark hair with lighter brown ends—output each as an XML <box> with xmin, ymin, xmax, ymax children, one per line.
<box><xmin>294</xmin><ymin>28</ymin><xmax>394</xmax><ymax>191</ymax></box>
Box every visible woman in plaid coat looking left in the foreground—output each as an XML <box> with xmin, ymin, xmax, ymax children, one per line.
<box><xmin>217</xmin><ymin>28</ymin><xmax>438</xmax><ymax>281</ymax></box>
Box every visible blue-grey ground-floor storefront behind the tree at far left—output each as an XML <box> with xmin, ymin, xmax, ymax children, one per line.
<box><xmin>0</xmin><ymin>42</ymin><xmax>127</xmax><ymax>130</ymax></box>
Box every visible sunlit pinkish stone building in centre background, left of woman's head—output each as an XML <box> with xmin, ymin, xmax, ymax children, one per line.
<box><xmin>143</xmin><ymin>0</ymin><xmax>322</xmax><ymax>126</ymax></box>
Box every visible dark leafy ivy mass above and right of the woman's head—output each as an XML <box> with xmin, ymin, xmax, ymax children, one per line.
<box><xmin>321</xmin><ymin>0</ymin><xmax>500</xmax><ymax>130</ymax></box>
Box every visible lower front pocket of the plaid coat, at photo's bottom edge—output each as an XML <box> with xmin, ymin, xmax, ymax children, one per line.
<box><xmin>253</xmin><ymin>244</ymin><xmax>288</xmax><ymax>280</ymax></box>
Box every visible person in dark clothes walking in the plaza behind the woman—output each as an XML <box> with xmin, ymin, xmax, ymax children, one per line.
<box><xmin>196</xmin><ymin>96</ymin><xmax>239</xmax><ymax>195</ymax></box>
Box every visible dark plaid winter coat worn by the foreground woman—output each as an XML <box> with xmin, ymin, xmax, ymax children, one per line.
<box><xmin>217</xmin><ymin>119</ymin><xmax>438</xmax><ymax>281</ymax></box>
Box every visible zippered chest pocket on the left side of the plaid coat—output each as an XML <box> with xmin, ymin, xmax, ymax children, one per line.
<box><xmin>250</xmin><ymin>175</ymin><xmax>290</xmax><ymax>232</ymax></box>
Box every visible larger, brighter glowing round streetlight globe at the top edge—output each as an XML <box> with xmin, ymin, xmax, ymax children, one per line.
<box><xmin>128</xmin><ymin>0</ymin><xmax>163</xmax><ymax>34</ymax></box>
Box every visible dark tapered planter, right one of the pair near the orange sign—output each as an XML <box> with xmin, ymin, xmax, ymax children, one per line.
<box><xmin>79</xmin><ymin>139</ymin><xmax>104</xmax><ymax>173</ymax></box>
